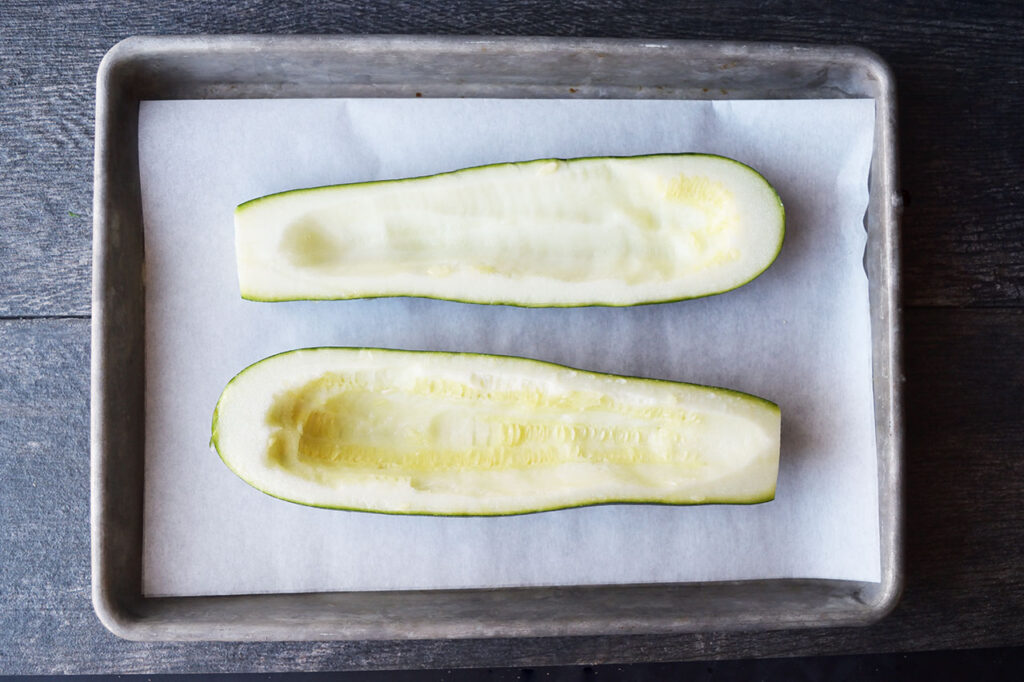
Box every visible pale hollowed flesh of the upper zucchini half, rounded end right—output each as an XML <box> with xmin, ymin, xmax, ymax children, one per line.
<box><xmin>234</xmin><ymin>154</ymin><xmax>784</xmax><ymax>306</ymax></box>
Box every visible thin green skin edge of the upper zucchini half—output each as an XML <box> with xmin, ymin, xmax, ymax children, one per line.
<box><xmin>236</xmin><ymin>153</ymin><xmax>785</xmax><ymax>308</ymax></box>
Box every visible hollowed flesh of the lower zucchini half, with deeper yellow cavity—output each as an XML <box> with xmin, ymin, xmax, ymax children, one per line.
<box><xmin>212</xmin><ymin>348</ymin><xmax>780</xmax><ymax>515</ymax></box>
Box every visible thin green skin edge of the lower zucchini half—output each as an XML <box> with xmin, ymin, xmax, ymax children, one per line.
<box><xmin>210</xmin><ymin>346</ymin><xmax>779</xmax><ymax>517</ymax></box>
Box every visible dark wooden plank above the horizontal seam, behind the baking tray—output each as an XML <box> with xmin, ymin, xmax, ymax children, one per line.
<box><xmin>0</xmin><ymin>0</ymin><xmax>1024</xmax><ymax>316</ymax></box>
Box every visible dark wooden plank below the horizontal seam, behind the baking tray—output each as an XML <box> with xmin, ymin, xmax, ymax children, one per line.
<box><xmin>0</xmin><ymin>309</ymin><xmax>1024</xmax><ymax>674</ymax></box>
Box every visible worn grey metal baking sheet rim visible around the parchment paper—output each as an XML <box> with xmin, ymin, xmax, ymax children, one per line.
<box><xmin>92</xmin><ymin>37</ymin><xmax>901</xmax><ymax>640</ymax></box>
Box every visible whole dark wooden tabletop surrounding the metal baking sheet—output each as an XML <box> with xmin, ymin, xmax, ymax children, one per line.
<box><xmin>0</xmin><ymin>0</ymin><xmax>1024</xmax><ymax>674</ymax></box>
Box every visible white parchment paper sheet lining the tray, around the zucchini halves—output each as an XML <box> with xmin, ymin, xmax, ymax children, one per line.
<box><xmin>139</xmin><ymin>99</ymin><xmax>880</xmax><ymax>596</ymax></box>
